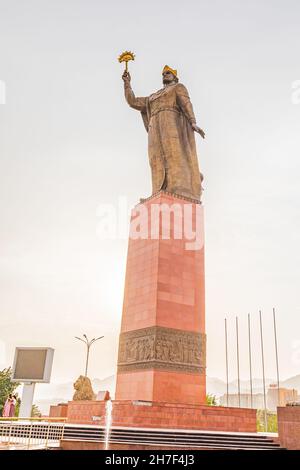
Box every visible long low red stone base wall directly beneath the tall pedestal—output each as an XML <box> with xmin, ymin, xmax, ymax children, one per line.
<box><xmin>68</xmin><ymin>401</ymin><xmax>256</xmax><ymax>432</ymax></box>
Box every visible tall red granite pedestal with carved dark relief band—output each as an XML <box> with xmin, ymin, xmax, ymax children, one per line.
<box><xmin>116</xmin><ymin>192</ymin><xmax>205</xmax><ymax>404</ymax></box>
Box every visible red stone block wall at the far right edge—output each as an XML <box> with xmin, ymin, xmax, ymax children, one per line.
<box><xmin>277</xmin><ymin>406</ymin><xmax>300</xmax><ymax>450</ymax></box>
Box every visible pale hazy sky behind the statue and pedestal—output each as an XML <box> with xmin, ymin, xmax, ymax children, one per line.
<box><xmin>0</xmin><ymin>0</ymin><xmax>300</xmax><ymax>398</ymax></box>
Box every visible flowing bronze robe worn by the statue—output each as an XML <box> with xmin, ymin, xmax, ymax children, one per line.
<box><xmin>125</xmin><ymin>83</ymin><xmax>201</xmax><ymax>200</ymax></box>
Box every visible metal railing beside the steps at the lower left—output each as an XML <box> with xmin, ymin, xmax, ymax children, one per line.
<box><xmin>0</xmin><ymin>417</ymin><xmax>66</xmax><ymax>450</ymax></box>
